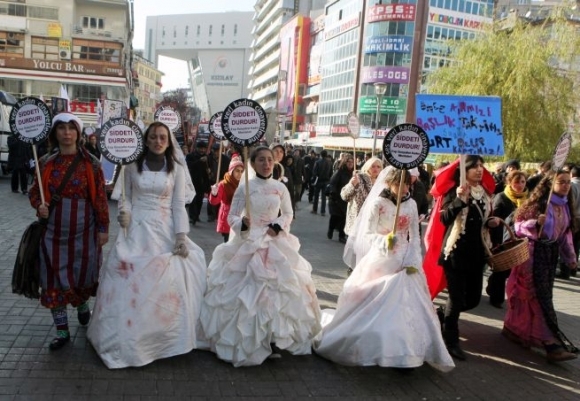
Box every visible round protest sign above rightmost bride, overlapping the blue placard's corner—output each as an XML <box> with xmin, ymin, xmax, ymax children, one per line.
<box><xmin>383</xmin><ymin>124</ymin><xmax>429</xmax><ymax>170</ymax></box>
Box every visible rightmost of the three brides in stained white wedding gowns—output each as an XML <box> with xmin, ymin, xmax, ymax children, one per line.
<box><xmin>313</xmin><ymin>167</ymin><xmax>454</xmax><ymax>371</ymax></box>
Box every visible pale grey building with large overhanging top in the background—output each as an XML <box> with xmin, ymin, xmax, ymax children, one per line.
<box><xmin>144</xmin><ymin>11</ymin><xmax>253</xmax><ymax>120</ymax></box>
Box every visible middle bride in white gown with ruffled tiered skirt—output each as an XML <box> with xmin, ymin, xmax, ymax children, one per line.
<box><xmin>200</xmin><ymin>147</ymin><xmax>320</xmax><ymax>367</ymax></box>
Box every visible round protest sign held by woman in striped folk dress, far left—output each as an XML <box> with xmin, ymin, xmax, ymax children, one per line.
<box><xmin>8</xmin><ymin>97</ymin><xmax>52</xmax><ymax>144</ymax></box>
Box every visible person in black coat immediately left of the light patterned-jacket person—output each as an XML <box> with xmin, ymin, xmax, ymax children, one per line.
<box><xmin>327</xmin><ymin>154</ymin><xmax>354</xmax><ymax>244</ymax></box>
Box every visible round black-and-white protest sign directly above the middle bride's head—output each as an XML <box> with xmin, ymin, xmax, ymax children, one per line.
<box><xmin>222</xmin><ymin>99</ymin><xmax>268</xmax><ymax>146</ymax></box>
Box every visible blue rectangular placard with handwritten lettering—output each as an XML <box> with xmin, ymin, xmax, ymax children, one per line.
<box><xmin>416</xmin><ymin>94</ymin><xmax>504</xmax><ymax>156</ymax></box>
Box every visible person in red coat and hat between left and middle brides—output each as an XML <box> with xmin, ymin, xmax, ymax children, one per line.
<box><xmin>209</xmin><ymin>154</ymin><xmax>244</xmax><ymax>242</ymax></box>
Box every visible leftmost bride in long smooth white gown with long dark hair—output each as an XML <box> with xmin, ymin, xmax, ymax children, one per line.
<box><xmin>87</xmin><ymin>122</ymin><xmax>206</xmax><ymax>369</ymax></box>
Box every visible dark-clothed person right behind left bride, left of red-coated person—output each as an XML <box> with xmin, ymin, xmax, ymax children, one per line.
<box><xmin>185</xmin><ymin>141</ymin><xmax>211</xmax><ymax>225</ymax></box>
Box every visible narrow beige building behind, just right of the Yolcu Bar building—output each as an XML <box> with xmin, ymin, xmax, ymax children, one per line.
<box><xmin>133</xmin><ymin>51</ymin><xmax>164</xmax><ymax>126</ymax></box>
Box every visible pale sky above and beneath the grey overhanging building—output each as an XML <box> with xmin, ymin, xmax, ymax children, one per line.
<box><xmin>133</xmin><ymin>0</ymin><xmax>256</xmax><ymax>92</ymax></box>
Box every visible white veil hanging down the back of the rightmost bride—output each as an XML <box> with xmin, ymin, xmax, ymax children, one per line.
<box><xmin>342</xmin><ymin>166</ymin><xmax>394</xmax><ymax>269</ymax></box>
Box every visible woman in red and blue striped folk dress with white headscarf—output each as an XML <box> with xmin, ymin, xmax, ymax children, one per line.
<box><xmin>30</xmin><ymin>113</ymin><xmax>109</xmax><ymax>350</ymax></box>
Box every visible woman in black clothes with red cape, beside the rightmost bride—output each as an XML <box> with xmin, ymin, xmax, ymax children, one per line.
<box><xmin>423</xmin><ymin>155</ymin><xmax>499</xmax><ymax>360</ymax></box>
